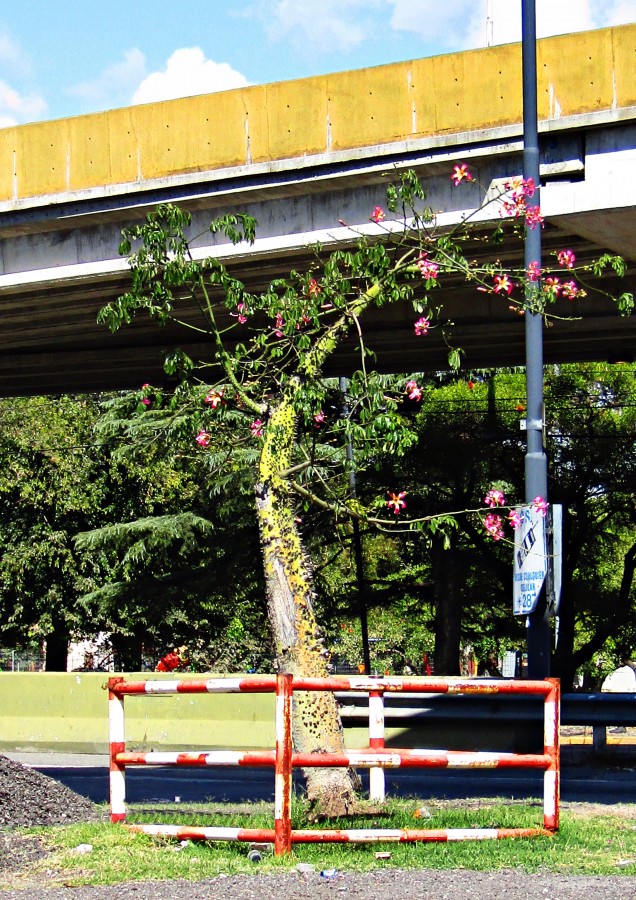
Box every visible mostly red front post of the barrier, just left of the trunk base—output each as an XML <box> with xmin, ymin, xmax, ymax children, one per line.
<box><xmin>274</xmin><ymin>674</ymin><xmax>294</xmax><ymax>856</ymax></box>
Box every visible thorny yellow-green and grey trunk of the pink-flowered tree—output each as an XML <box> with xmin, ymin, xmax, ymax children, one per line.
<box><xmin>256</xmin><ymin>400</ymin><xmax>362</xmax><ymax>815</ymax></box>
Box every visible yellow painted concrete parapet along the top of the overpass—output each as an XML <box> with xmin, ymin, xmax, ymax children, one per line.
<box><xmin>0</xmin><ymin>24</ymin><xmax>636</xmax><ymax>202</ymax></box>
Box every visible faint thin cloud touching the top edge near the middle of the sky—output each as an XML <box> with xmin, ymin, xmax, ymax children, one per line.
<box><xmin>261</xmin><ymin>0</ymin><xmax>385</xmax><ymax>54</ymax></box>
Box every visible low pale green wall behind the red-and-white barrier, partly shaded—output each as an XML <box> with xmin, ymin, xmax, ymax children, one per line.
<box><xmin>0</xmin><ymin>672</ymin><xmax>541</xmax><ymax>753</ymax></box>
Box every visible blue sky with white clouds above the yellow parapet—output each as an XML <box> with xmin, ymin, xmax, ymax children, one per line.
<box><xmin>0</xmin><ymin>0</ymin><xmax>636</xmax><ymax>127</ymax></box>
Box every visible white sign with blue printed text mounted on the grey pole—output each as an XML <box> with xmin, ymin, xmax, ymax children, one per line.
<box><xmin>512</xmin><ymin>506</ymin><xmax>548</xmax><ymax>616</ymax></box>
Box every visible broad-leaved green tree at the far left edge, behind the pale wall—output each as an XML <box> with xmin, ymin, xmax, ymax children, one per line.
<box><xmin>0</xmin><ymin>398</ymin><xmax>105</xmax><ymax>671</ymax></box>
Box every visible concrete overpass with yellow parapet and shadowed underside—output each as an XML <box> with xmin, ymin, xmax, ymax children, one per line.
<box><xmin>0</xmin><ymin>25</ymin><xmax>636</xmax><ymax>396</ymax></box>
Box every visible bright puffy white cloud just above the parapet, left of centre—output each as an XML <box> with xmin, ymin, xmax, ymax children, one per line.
<box><xmin>130</xmin><ymin>47</ymin><xmax>249</xmax><ymax>103</ymax></box>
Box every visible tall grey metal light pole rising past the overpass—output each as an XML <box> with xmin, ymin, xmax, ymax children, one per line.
<box><xmin>521</xmin><ymin>0</ymin><xmax>550</xmax><ymax>678</ymax></box>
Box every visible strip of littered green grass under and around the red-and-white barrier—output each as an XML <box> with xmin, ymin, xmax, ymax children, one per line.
<box><xmin>0</xmin><ymin>799</ymin><xmax>636</xmax><ymax>888</ymax></box>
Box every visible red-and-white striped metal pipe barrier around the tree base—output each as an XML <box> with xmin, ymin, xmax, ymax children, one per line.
<box><xmin>108</xmin><ymin>675</ymin><xmax>560</xmax><ymax>854</ymax></box>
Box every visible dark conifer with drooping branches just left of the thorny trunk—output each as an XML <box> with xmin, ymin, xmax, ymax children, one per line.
<box><xmin>75</xmin><ymin>412</ymin><xmax>272</xmax><ymax>672</ymax></box>
